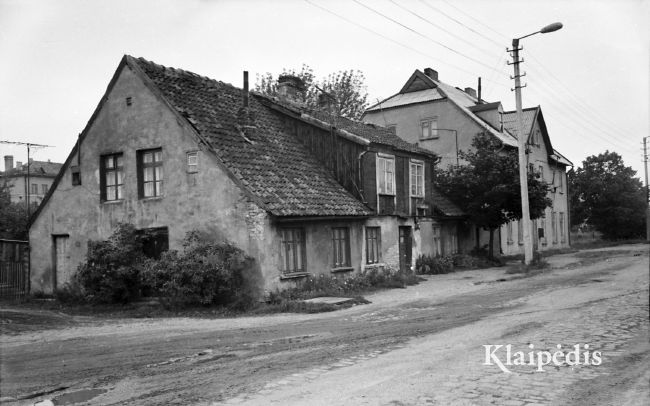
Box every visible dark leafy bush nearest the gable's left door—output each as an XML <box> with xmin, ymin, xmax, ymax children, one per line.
<box><xmin>74</xmin><ymin>223</ymin><xmax>145</xmax><ymax>303</ymax></box>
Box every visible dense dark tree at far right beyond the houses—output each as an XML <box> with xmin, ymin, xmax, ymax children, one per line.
<box><xmin>569</xmin><ymin>151</ymin><xmax>647</xmax><ymax>239</ymax></box>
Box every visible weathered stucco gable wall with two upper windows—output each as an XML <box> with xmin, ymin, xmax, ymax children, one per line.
<box><xmin>30</xmin><ymin>67</ymin><xmax>268</xmax><ymax>292</ymax></box>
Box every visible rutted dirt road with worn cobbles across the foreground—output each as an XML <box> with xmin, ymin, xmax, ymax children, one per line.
<box><xmin>0</xmin><ymin>245</ymin><xmax>650</xmax><ymax>405</ymax></box>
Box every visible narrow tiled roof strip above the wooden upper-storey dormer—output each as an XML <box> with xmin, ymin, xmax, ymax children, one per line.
<box><xmin>308</xmin><ymin>110</ymin><xmax>436</xmax><ymax>156</ymax></box>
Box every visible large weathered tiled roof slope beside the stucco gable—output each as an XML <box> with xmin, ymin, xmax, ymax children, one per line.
<box><xmin>125</xmin><ymin>56</ymin><xmax>372</xmax><ymax>216</ymax></box>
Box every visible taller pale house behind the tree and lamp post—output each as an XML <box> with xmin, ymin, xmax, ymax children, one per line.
<box><xmin>363</xmin><ymin>68</ymin><xmax>572</xmax><ymax>255</ymax></box>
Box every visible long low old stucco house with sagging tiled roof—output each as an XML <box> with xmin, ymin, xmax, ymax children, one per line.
<box><xmin>30</xmin><ymin>56</ymin><xmax>463</xmax><ymax>292</ymax></box>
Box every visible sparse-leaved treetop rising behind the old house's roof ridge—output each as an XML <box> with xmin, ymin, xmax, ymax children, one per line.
<box><xmin>255</xmin><ymin>64</ymin><xmax>368</xmax><ymax>120</ymax></box>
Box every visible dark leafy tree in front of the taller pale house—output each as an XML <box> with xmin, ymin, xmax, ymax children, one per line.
<box><xmin>435</xmin><ymin>133</ymin><xmax>553</xmax><ymax>258</ymax></box>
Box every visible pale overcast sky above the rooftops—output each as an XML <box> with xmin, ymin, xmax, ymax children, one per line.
<box><xmin>0</xmin><ymin>0</ymin><xmax>650</xmax><ymax>179</ymax></box>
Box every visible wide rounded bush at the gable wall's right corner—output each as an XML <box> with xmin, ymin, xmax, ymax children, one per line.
<box><xmin>142</xmin><ymin>232</ymin><xmax>256</xmax><ymax>307</ymax></box>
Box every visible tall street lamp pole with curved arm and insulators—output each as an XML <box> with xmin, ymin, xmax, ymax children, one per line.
<box><xmin>511</xmin><ymin>23</ymin><xmax>562</xmax><ymax>265</ymax></box>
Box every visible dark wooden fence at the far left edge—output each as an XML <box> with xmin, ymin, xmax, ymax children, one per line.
<box><xmin>0</xmin><ymin>239</ymin><xmax>29</xmax><ymax>300</ymax></box>
